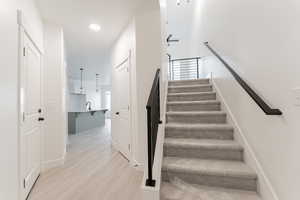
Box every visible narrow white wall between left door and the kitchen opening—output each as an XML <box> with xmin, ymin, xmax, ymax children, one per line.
<box><xmin>43</xmin><ymin>22</ymin><xmax>67</xmax><ymax>170</ymax></box>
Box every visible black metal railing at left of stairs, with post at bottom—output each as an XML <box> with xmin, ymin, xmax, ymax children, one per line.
<box><xmin>146</xmin><ymin>69</ymin><xmax>161</xmax><ymax>187</ymax></box>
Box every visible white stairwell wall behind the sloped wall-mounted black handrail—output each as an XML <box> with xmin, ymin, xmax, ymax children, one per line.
<box><xmin>169</xmin><ymin>0</ymin><xmax>300</xmax><ymax>200</ymax></box>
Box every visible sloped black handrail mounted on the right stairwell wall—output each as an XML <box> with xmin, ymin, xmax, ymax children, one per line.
<box><xmin>204</xmin><ymin>42</ymin><xmax>282</xmax><ymax>115</ymax></box>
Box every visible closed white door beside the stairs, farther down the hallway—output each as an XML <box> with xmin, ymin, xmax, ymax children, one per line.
<box><xmin>113</xmin><ymin>59</ymin><xmax>131</xmax><ymax>160</ymax></box>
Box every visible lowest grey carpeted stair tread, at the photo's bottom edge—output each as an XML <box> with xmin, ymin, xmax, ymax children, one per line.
<box><xmin>160</xmin><ymin>182</ymin><xmax>261</xmax><ymax>200</ymax></box>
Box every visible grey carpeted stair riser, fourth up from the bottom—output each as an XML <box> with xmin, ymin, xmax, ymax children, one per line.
<box><xmin>167</xmin><ymin>114</ymin><xmax>226</xmax><ymax>124</ymax></box>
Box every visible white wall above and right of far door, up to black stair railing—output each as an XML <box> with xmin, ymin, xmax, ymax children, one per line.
<box><xmin>111</xmin><ymin>1</ymin><xmax>161</xmax><ymax>165</ymax></box>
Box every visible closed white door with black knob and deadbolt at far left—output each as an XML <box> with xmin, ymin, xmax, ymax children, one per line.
<box><xmin>20</xmin><ymin>33</ymin><xmax>43</xmax><ymax>199</ymax></box>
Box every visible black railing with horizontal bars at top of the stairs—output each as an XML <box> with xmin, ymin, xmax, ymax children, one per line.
<box><xmin>169</xmin><ymin>57</ymin><xmax>201</xmax><ymax>80</ymax></box>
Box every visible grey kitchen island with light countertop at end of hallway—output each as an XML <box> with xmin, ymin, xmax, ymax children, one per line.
<box><xmin>68</xmin><ymin>109</ymin><xmax>108</xmax><ymax>134</ymax></box>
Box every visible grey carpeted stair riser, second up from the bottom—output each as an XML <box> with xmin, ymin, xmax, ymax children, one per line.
<box><xmin>164</xmin><ymin>145</ymin><xmax>243</xmax><ymax>161</ymax></box>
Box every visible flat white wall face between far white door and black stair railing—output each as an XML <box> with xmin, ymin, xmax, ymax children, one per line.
<box><xmin>135</xmin><ymin>1</ymin><xmax>162</xmax><ymax>164</ymax></box>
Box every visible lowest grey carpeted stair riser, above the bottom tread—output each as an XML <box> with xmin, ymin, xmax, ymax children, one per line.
<box><xmin>162</xmin><ymin>170</ymin><xmax>257</xmax><ymax>191</ymax></box>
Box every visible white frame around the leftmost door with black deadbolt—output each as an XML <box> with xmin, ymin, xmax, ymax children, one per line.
<box><xmin>17</xmin><ymin>10</ymin><xmax>44</xmax><ymax>200</ymax></box>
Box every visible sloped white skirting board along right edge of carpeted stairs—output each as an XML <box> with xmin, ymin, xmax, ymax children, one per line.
<box><xmin>211</xmin><ymin>77</ymin><xmax>279</xmax><ymax>200</ymax></box>
